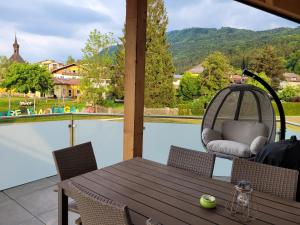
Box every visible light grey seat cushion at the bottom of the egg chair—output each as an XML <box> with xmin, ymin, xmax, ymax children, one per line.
<box><xmin>207</xmin><ymin>140</ymin><xmax>251</xmax><ymax>158</ymax></box>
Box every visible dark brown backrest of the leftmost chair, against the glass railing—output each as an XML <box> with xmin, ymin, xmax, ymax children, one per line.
<box><xmin>52</xmin><ymin>142</ymin><xmax>97</xmax><ymax>180</ymax></box>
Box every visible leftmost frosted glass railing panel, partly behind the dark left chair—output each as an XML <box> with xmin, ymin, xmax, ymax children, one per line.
<box><xmin>0</xmin><ymin>120</ymin><xmax>70</xmax><ymax>190</ymax></box>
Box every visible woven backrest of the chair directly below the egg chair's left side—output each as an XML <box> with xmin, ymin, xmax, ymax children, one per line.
<box><xmin>167</xmin><ymin>145</ymin><xmax>215</xmax><ymax>177</ymax></box>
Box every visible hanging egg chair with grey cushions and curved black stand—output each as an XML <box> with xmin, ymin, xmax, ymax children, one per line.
<box><xmin>201</xmin><ymin>70</ymin><xmax>285</xmax><ymax>159</ymax></box>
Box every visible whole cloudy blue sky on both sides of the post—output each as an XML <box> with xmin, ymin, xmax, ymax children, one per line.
<box><xmin>0</xmin><ymin>0</ymin><xmax>299</xmax><ymax>62</ymax></box>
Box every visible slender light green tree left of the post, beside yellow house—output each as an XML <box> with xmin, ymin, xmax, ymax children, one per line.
<box><xmin>81</xmin><ymin>29</ymin><xmax>115</xmax><ymax>105</ymax></box>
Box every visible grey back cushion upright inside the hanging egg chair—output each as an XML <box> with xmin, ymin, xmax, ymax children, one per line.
<box><xmin>222</xmin><ymin>120</ymin><xmax>268</xmax><ymax>145</ymax></box>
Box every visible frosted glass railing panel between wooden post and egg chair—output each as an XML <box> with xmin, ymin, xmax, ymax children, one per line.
<box><xmin>143</xmin><ymin>118</ymin><xmax>232</xmax><ymax>177</ymax></box>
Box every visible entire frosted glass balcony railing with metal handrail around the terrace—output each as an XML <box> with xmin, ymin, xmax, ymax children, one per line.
<box><xmin>0</xmin><ymin>113</ymin><xmax>300</xmax><ymax>190</ymax></box>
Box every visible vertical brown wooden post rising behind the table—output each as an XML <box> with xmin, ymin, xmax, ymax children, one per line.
<box><xmin>123</xmin><ymin>0</ymin><xmax>147</xmax><ymax>160</ymax></box>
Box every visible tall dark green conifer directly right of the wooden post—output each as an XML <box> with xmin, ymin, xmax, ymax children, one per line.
<box><xmin>145</xmin><ymin>0</ymin><xmax>175</xmax><ymax>107</ymax></box>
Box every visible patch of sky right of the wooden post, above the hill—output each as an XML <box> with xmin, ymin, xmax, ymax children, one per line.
<box><xmin>166</xmin><ymin>0</ymin><xmax>298</xmax><ymax>30</ymax></box>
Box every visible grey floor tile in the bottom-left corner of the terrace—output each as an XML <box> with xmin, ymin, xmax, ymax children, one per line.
<box><xmin>0</xmin><ymin>199</ymin><xmax>33</xmax><ymax>225</ymax></box>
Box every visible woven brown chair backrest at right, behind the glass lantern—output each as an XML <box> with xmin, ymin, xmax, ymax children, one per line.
<box><xmin>231</xmin><ymin>158</ymin><xmax>299</xmax><ymax>200</ymax></box>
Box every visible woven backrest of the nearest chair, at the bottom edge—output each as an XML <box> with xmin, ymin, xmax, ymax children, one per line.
<box><xmin>69</xmin><ymin>182</ymin><xmax>131</xmax><ymax>225</ymax></box>
